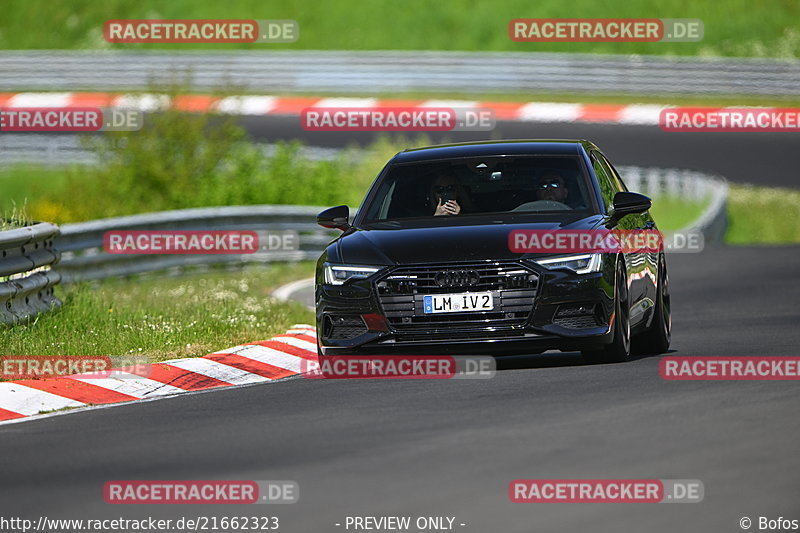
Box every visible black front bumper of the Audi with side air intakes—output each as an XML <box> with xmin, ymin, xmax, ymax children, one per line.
<box><xmin>315</xmin><ymin>261</ymin><xmax>614</xmax><ymax>355</ymax></box>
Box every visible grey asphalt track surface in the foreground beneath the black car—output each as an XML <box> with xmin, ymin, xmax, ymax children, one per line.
<box><xmin>0</xmin><ymin>120</ymin><xmax>800</xmax><ymax>533</ymax></box>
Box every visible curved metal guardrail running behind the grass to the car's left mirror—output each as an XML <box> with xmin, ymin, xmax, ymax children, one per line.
<box><xmin>56</xmin><ymin>205</ymin><xmax>338</xmax><ymax>283</ymax></box>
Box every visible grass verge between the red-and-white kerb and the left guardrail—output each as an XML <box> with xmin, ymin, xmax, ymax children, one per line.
<box><xmin>0</xmin><ymin>261</ymin><xmax>314</xmax><ymax>361</ymax></box>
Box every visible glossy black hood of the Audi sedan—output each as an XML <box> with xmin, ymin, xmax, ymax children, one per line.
<box><xmin>328</xmin><ymin>215</ymin><xmax>603</xmax><ymax>265</ymax></box>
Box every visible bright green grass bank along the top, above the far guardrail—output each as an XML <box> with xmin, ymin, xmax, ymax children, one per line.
<box><xmin>0</xmin><ymin>0</ymin><xmax>800</xmax><ymax>58</ymax></box>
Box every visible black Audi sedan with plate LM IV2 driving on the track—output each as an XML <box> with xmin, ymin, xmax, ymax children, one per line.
<box><xmin>315</xmin><ymin>140</ymin><xmax>671</xmax><ymax>361</ymax></box>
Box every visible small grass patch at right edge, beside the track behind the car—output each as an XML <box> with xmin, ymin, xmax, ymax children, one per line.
<box><xmin>725</xmin><ymin>185</ymin><xmax>800</xmax><ymax>244</ymax></box>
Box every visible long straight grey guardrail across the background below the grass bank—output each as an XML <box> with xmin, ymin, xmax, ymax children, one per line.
<box><xmin>0</xmin><ymin>50</ymin><xmax>800</xmax><ymax>96</ymax></box>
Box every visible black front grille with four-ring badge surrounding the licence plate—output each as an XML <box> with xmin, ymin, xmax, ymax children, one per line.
<box><xmin>377</xmin><ymin>262</ymin><xmax>539</xmax><ymax>333</ymax></box>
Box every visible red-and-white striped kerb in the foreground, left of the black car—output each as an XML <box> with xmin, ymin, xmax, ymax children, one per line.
<box><xmin>0</xmin><ymin>324</ymin><xmax>317</xmax><ymax>421</ymax></box>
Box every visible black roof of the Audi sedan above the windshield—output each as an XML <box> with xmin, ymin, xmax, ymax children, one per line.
<box><xmin>392</xmin><ymin>139</ymin><xmax>597</xmax><ymax>163</ymax></box>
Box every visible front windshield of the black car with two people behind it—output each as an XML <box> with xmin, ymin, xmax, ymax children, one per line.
<box><xmin>365</xmin><ymin>156</ymin><xmax>591</xmax><ymax>222</ymax></box>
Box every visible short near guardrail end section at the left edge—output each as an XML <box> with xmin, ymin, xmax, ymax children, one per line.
<box><xmin>0</xmin><ymin>222</ymin><xmax>61</xmax><ymax>324</ymax></box>
